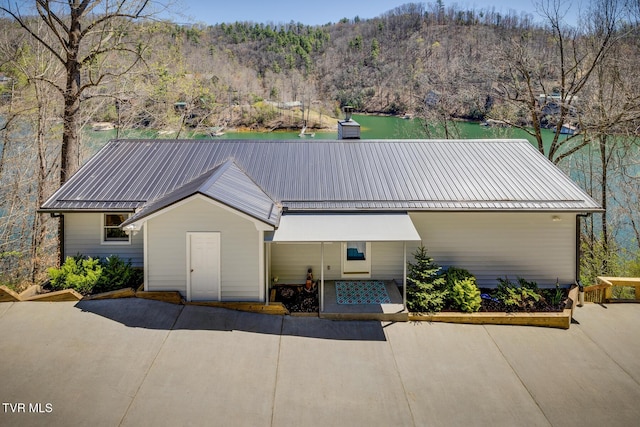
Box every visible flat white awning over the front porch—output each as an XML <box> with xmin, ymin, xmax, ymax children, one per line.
<box><xmin>272</xmin><ymin>213</ymin><xmax>421</xmax><ymax>242</ymax></box>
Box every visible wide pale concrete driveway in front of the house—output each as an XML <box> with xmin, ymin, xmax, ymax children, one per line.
<box><xmin>0</xmin><ymin>299</ymin><xmax>640</xmax><ymax>427</ymax></box>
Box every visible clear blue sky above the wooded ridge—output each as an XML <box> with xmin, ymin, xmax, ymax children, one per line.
<box><xmin>164</xmin><ymin>0</ymin><xmax>577</xmax><ymax>25</ymax></box>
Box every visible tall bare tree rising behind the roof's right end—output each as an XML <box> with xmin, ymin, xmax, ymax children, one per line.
<box><xmin>497</xmin><ymin>0</ymin><xmax>621</xmax><ymax>163</ymax></box>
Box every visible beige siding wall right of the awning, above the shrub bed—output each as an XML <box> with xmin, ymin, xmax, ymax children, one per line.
<box><xmin>408</xmin><ymin>212</ymin><xmax>576</xmax><ymax>286</ymax></box>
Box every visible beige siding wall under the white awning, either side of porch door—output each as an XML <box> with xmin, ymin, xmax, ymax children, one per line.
<box><xmin>271</xmin><ymin>242</ymin><xmax>410</xmax><ymax>284</ymax></box>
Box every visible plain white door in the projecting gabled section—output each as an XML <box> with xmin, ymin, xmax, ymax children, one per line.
<box><xmin>187</xmin><ymin>232</ymin><xmax>220</xmax><ymax>301</ymax></box>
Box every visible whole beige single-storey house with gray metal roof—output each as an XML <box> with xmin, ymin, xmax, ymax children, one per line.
<box><xmin>40</xmin><ymin>122</ymin><xmax>600</xmax><ymax>311</ymax></box>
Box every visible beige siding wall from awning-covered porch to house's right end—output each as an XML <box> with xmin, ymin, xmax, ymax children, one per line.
<box><xmin>271</xmin><ymin>212</ymin><xmax>576</xmax><ymax>287</ymax></box>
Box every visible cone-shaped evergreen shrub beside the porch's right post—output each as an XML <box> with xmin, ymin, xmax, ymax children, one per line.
<box><xmin>407</xmin><ymin>246</ymin><xmax>448</xmax><ymax>313</ymax></box>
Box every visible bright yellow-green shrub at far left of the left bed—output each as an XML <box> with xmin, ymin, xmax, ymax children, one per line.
<box><xmin>48</xmin><ymin>255</ymin><xmax>102</xmax><ymax>295</ymax></box>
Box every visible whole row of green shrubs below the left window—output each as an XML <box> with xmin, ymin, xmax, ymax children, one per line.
<box><xmin>48</xmin><ymin>254</ymin><xmax>143</xmax><ymax>295</ymax></box>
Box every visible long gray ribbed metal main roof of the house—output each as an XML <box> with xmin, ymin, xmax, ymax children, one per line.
<box><xmin>41</xmin><ymin>140</ymin><xmax>600</xmax><ymax>223</ymax></box>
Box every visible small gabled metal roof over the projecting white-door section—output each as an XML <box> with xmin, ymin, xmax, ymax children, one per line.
<box><xmin>122</xmin><ymin>159</ymin><xmax>280</xmax><ymax>227</ymax></box>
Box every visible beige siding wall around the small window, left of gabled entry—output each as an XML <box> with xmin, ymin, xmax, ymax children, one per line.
<box><xmin>64</xmin><ymin>213</ymin><xmax>144</xmax><ymax>267</ymax></box>
